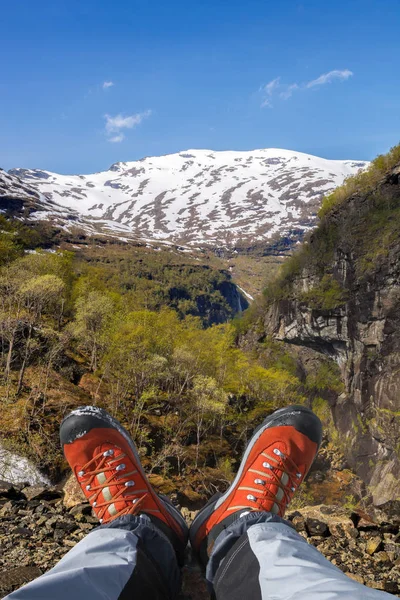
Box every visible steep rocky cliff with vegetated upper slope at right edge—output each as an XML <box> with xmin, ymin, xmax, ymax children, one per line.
<box><xmin>264</xmin><ymin>165</ymin><xmax>400</xmax><ymax>506</ymax></box>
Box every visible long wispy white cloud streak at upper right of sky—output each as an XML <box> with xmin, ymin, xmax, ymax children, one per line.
<box><xmin>259</xmin><ymin>69</ymin><xmax>353</xmax><ymax>108</ymax></box>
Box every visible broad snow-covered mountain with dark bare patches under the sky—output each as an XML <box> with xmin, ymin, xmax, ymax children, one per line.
<box><xmin>5</xmin><ymin>148</ymin><xmax>368</xmax><ymax>247</ymax></box>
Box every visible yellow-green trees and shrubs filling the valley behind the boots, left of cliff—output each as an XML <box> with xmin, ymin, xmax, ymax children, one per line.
<box><xmin>0</xmin><ymin>214</ymin><xmax>346</xmax><ymax>502</ymax></box>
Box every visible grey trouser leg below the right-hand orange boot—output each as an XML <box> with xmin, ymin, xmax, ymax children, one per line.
<box><xmin>207</xmin><ymin>512</ymin><xmax>394</xmax><ymax>600</ymax></box>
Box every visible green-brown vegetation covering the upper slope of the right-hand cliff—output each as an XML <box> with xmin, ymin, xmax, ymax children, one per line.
<box><xmin>250</xmin><ymin>145</ymin><xmax>400</xmax><ymax>322</ymax></box>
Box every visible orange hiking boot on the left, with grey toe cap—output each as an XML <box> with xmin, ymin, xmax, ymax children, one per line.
<box><xmin>60</xmin><ymin>406</ymin><xmax>188</xmax><ymax>550</ymax></box>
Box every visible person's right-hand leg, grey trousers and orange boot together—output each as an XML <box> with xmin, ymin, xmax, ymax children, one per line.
<box><xmin>190</xmin><ymin>406</ymin><xmax>391</xmax><ymax>600</ymax></box>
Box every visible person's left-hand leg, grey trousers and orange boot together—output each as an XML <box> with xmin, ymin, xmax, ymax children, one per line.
<box><xmin>4</xmin><ymin>406</ymin><xmax>188</xmax><ymax>600</ymax></box>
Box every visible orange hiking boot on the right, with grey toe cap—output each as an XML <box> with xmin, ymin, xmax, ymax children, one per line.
<box><xmin>189</xmin><ymin>406</ymin><xmax>322</xmax><ymax>560</ymax></box>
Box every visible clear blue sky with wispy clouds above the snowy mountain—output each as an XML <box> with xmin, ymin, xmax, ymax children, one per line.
<box><xmin>0</xmin><ymin>0</ymin><xmax>400</xmax><ymax>173</ymax></box>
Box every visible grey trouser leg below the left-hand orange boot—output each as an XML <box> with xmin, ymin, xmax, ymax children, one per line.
<box><xmin>6</xmin><ymin>515</ymin><xmax>180</xmax><ymax>600</ymax></box>
